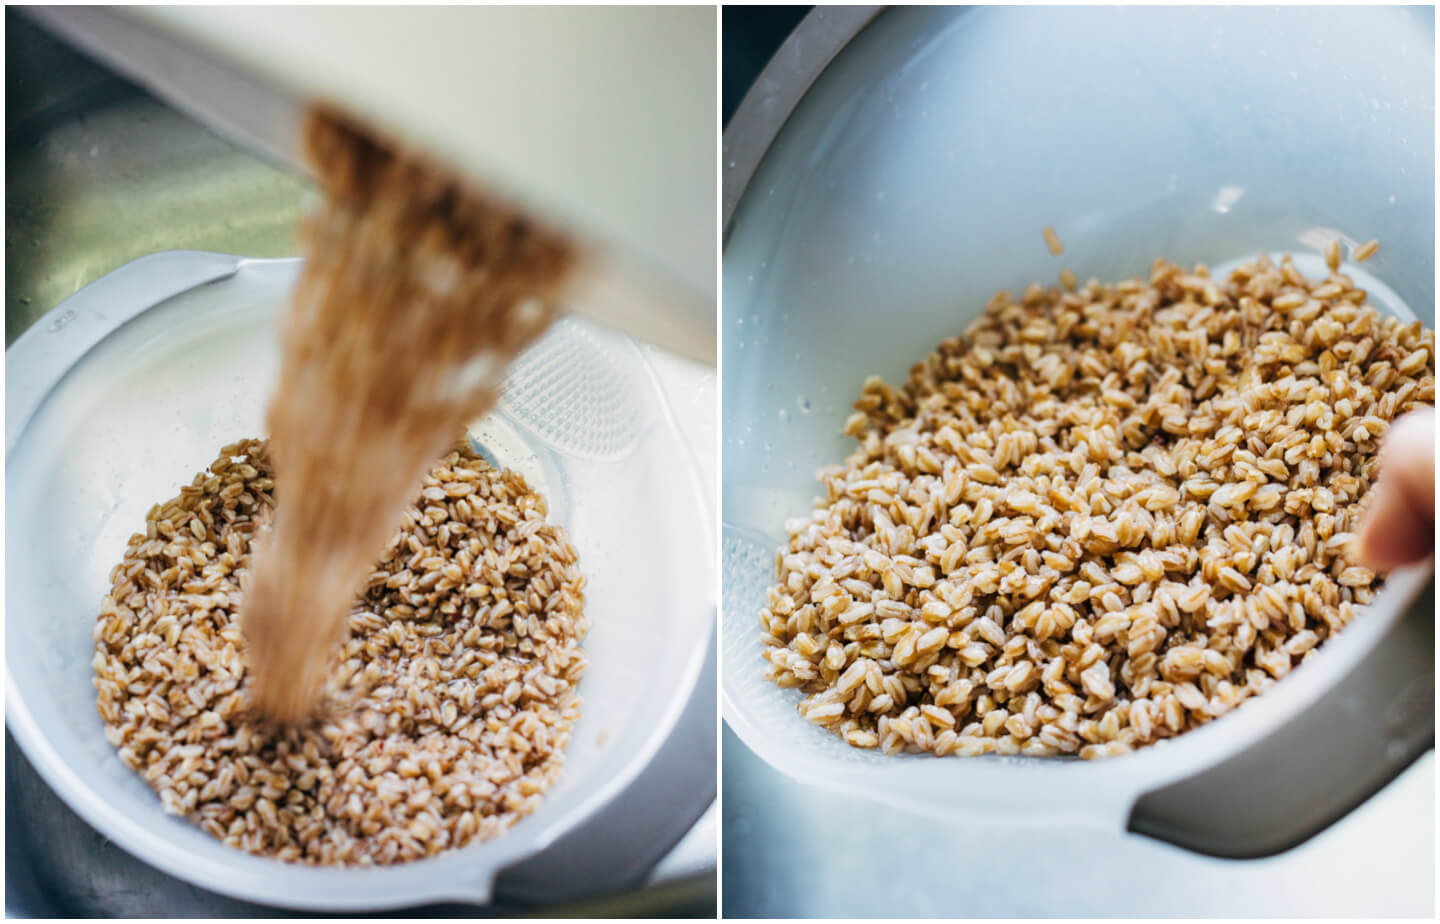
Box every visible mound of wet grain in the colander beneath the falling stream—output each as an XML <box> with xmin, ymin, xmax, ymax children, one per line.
<box><xmin>94</xmin><ymin>440</ymin><xmax>588</xmax><ymax>865</ymax></box>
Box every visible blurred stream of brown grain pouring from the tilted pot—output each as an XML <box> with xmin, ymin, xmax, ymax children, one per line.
<box><xmin>242</xmin><ymin>109</ymin><xmax>576</xmax><ymax>723</ymax></box>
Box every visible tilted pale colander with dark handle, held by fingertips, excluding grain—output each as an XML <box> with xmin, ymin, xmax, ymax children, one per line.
<box><xmin>721</xmin><ymin>7</ymin><xmax>1434</xmax><ymax>856</ymax></box>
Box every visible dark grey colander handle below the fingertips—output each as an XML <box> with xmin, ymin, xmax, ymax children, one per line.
<box><xmin>1128</xmin><ymin>574</ymin><xmax>1436</xmax><ymax>859</ymax></box>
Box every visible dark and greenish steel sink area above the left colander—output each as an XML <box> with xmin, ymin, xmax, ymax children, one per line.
<box><xmin>4</xmin><ymin>7</ymin><xmax>314</xmax><ymax>345</ymax></box>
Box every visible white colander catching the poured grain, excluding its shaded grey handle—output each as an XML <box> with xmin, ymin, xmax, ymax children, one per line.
<box><xmin>6</xmin><ymin>252</ymin><xmax>714</xmax><ymax>910</ymax></box>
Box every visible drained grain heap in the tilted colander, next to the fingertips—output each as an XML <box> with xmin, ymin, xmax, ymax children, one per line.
<box><xmin>760</xmin><ymin>245</ymin><xmax>1434</xmax><ymax>757</ymax></box>
